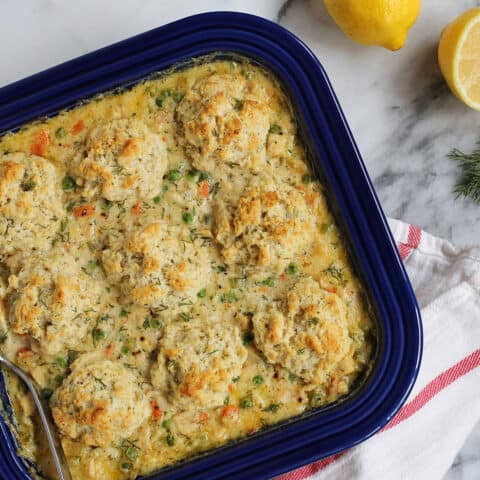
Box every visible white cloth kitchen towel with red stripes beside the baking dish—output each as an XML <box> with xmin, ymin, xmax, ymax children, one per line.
<box><xmin>277</xmin><ymin>220</ymin><xmax>480</xmax><ymax>480</ymax></box>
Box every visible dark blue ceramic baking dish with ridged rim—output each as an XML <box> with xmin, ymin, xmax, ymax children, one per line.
<box><xmin>0</xmin><ymin>12</ymin><xmax>422</xmax><ymax>480</ymax></box>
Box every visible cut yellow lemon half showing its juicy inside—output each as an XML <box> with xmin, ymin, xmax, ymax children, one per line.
<box><xmin>438</xmin><ymin>8</ymin><xmax>480</xmax><ymax>110</ymax></box>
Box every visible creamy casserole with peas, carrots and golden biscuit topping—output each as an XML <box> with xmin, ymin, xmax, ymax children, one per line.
<box><xmin>0</xmin><ymin>62</ymin><xmax>374</xmax><ymax>480</ymax></box>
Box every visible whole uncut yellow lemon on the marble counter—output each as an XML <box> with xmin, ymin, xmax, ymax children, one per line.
<box><xmin>324</xmin><ymin>0</ymin><xmax>420</xmax><ymax>50</ymax></box>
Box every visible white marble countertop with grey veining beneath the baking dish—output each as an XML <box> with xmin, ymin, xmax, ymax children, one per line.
<box><xmin>0</xmin><ymin>0</ymin><xmax>480</xmax><ymax>480</ymax></box>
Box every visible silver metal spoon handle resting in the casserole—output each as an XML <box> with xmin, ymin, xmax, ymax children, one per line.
<box><xmin>0</xmin><ymin>352</ymin><xmax>72</xmax><ymax>480</ymax></box>
